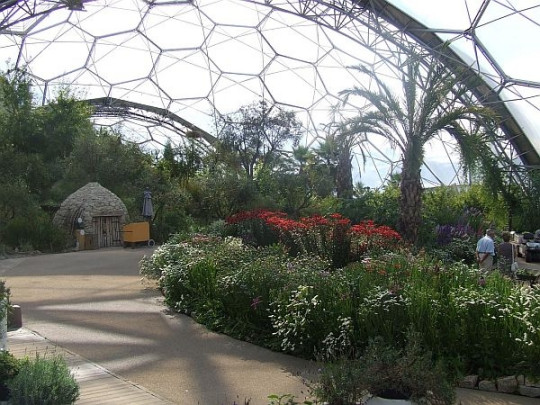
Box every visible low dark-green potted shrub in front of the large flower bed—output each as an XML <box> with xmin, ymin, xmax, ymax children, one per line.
<box><xmin>315</xmin><ymin>332</ymin><xmax>455</xmax><ymax>405</ymax></box>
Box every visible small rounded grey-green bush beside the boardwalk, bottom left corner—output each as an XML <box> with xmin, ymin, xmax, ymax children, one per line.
<box><xmin>8</xmin><ymin>355</ymin><xmax>79</xmax><ymax>405</ymax></box>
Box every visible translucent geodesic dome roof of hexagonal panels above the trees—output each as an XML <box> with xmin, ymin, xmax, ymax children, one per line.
<box><xmin>0</xmin><ymin>0</ymin><xmax>540</xmax><ymax>186</ymax></box>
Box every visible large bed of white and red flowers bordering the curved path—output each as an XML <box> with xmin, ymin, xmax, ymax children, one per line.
<box><xmin>141</xmin><ymin>213</ymin><xmax>540</xmax><ymax>400</ymax></box>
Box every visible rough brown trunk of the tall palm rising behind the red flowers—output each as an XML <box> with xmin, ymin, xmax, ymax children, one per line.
<box><xmin>398</xmin><ymin>159</ymin><xmax>423</xmax><ymax>244</ymax></box>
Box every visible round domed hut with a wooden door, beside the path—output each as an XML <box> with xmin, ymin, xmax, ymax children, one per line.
<box><xmin>53</xmin><ymin>183</ymin><xmax>128</xmax><ymax>249</ymax></box>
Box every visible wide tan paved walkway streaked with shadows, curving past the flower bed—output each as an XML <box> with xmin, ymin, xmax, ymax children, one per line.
<box><xmin>0</xmin><ymin>248</ymin><xmax>540</xmax><ymax>405</ymax></box>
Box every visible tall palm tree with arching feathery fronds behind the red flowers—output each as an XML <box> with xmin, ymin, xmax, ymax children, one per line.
<box><xmin>340</xmin><ymin>52</ymin><xmax>493</xmax><ymax>243</ymax></box>
